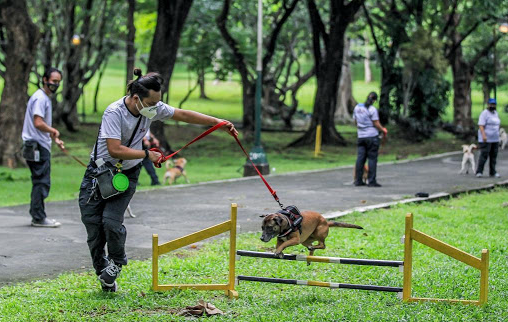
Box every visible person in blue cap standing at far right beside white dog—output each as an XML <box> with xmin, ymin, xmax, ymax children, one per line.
<box><xmin>476</xmin><ymin>98</ymin><xmax>501</xmax><ymax>178</ymax></box>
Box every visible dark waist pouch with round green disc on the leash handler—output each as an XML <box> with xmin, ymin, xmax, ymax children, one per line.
<box><xmin>92</xmin><ymin>162</ymin><xmax>129</xmax><ymax>199</ymax></box>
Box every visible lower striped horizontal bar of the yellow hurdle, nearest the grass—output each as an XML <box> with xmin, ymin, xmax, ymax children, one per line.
<box><xmin>237</xmin><ymin>275</ymin><xmax>402</xmax><ymax>292</ymax></box>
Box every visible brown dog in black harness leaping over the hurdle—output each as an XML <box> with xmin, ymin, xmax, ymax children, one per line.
<box><xmin>261</xmin><ymin>211</ymin><xmax>363</xmax><ymax>258</ymax></box>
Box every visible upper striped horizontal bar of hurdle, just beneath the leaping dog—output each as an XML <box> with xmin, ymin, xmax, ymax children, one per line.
<box><xmin>236</xmin><ymin>250</ymin><xmax>404</xmax><ymax>267</ymax></box>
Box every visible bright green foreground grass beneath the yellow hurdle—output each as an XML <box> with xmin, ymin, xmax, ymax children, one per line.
<box><xmin>0</xmin><ymin>189</ymin><xmax>508</xmax><ymax>321</ymax></box>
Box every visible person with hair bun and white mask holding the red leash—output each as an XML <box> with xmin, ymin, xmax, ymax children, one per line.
<box><xmin>79</xmin><ymin>68</ymin><xmax>238</xmax><ymax>292</ymax></box>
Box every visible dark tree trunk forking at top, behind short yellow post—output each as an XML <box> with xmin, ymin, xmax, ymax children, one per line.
<box><xmin>291</xmin><ymin>0</ymin><xmax>363</xmax><ymax>146</ymax></box>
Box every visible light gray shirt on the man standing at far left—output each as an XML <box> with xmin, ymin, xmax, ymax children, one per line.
<box><xmin>21</xmin><ymin>89</ymin><xmax>53</xmax><ymax>152</ymax></box>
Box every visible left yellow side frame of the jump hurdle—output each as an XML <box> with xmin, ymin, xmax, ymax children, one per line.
<box><xmin>152</xmin><ymin>203</ymin><xmax>238</xmax><ymax>298</ymax></box>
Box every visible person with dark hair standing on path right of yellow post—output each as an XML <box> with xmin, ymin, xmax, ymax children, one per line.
<box><xmin>353</xmin><ymin>92</ymin><xmax>388</xmax><ymax>187</ymax></box>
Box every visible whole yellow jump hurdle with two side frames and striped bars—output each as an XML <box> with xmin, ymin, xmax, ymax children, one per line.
<box><xmin>152</xmin><ymin>208</ymin><xmax>489</xmax><ymax>305</ymax></box>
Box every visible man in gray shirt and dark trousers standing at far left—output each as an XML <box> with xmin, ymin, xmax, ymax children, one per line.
<box><xmin>21</xmin><ymin>67</ymin><xmax>64</xmax><ymax>228</ymax></box>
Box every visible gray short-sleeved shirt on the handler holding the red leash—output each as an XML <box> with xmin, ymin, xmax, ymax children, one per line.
<box><xmin>90</xmin><ymin>97</ymin><xmax>175</xmax><ymax>170</ymax></box>
